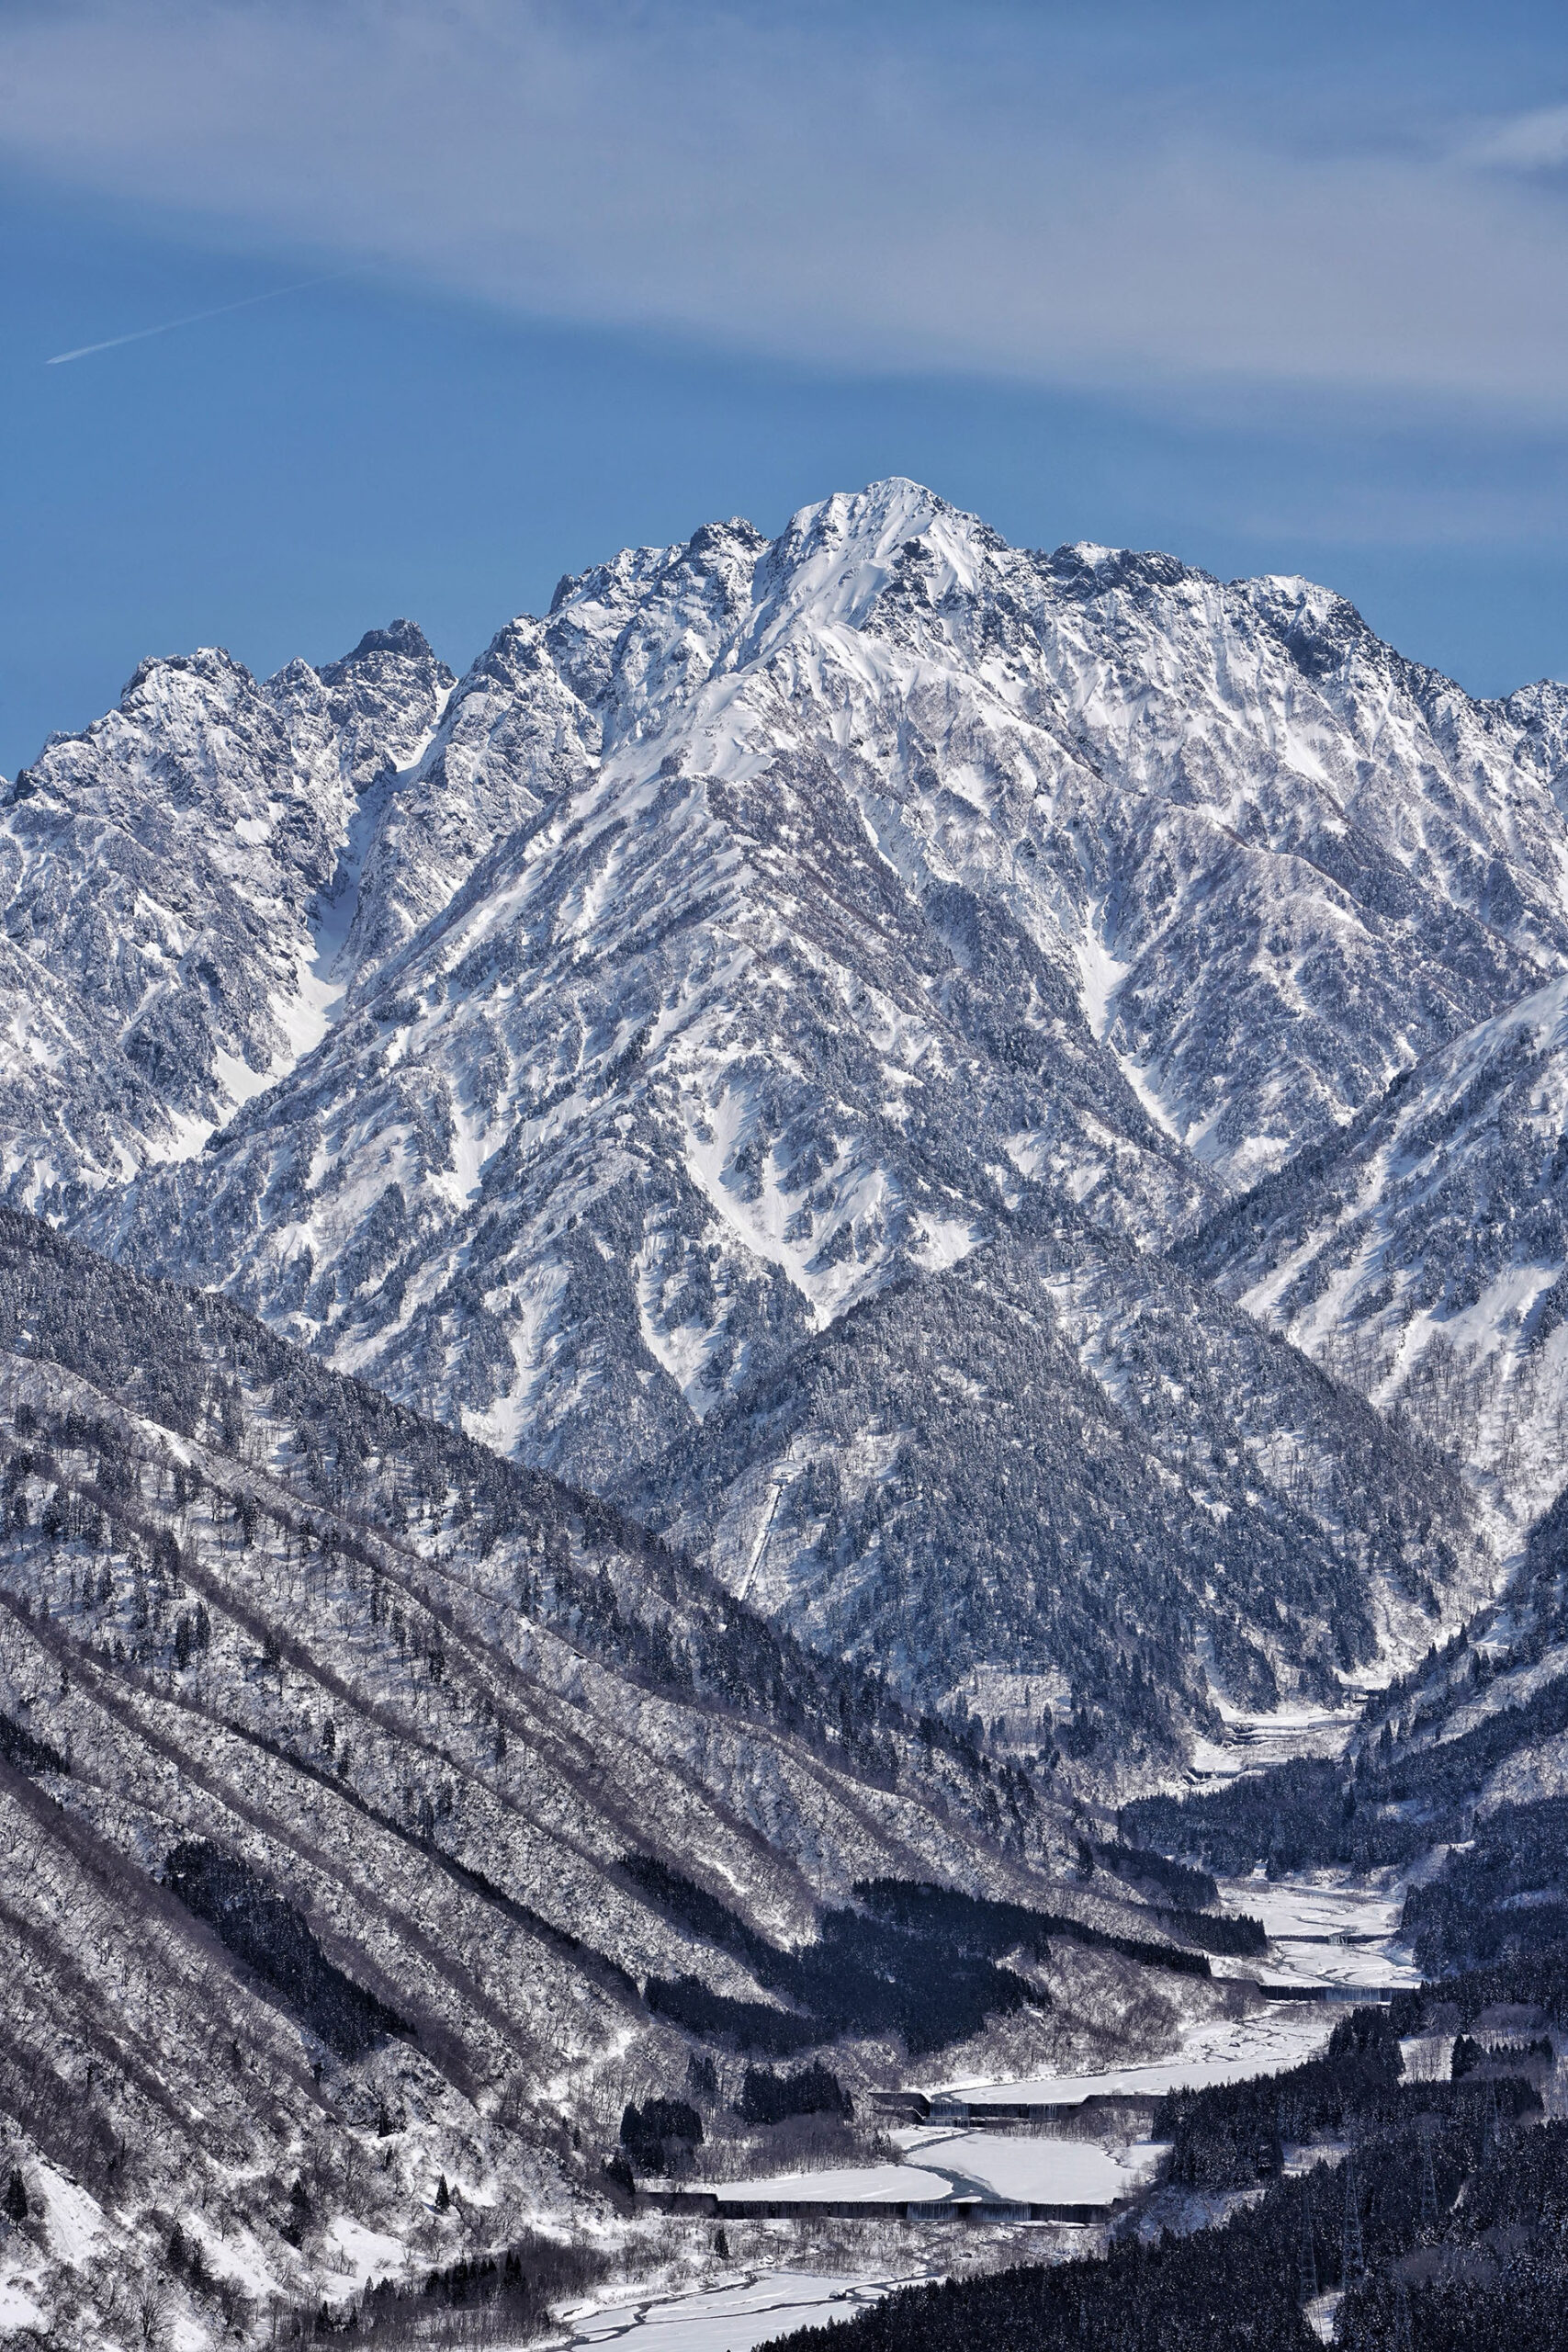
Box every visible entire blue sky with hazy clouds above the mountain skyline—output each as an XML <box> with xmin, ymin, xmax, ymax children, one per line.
<box><xmin>0</xmin><ymin>0</ymin><xmax>1568</xmax><ymax>774</ymax></box>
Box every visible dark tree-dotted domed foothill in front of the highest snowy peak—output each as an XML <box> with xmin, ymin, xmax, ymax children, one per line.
<box><xmin>621</xmin><ymin>1235</ymin><xmax>1491</xmax><ymax>1769</ymax></box>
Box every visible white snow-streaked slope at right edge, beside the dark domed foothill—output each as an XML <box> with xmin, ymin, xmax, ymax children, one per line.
<box><xmin>1182</xmin><ymin>981</ymin><xmax>1568</xmax><ymax>1529</ymax></box>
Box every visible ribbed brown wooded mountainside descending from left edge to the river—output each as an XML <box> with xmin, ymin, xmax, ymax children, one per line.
<box><xmin>0</xmin><ymin>1211</ymin><xmax>1220</xmax><ymax>2345</ymax></box>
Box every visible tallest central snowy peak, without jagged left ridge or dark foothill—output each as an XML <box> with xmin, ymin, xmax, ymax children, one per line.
<box><xmin>94</xmin><ymin>482</ymin><xmax>1568</xmax><ymax>1420</ymax></box>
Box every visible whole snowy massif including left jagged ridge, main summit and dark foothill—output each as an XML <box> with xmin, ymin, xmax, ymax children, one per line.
<box><xmin>12</xmin><ymin>480</ymin><xmax>1568</xmax><ymax>1736</ymax></box>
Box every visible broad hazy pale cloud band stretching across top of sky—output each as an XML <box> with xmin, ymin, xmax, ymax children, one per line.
<box><xmin>0</xmin><ymin>0</ymin><xmax>1568</xmax><ymax>407</ymax></box>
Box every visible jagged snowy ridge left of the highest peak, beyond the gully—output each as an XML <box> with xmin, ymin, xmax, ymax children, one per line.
<box><xmin>0</xmin><ymin>621</ymin><xmax>451</xmax><ymax>1216</ymax></box>
